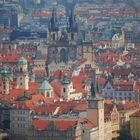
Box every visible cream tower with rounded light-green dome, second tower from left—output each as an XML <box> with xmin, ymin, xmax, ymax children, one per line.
<box><xmin>17</xmin><ymin>57</ymin><xmax>29</xmax><ymax>90</ymax></box>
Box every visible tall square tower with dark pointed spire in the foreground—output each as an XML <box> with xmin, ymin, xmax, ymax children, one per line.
<box><xmin>87</xmin><ymin>70</ymin><xmax>104</xmax><ymax>140</ymax></box>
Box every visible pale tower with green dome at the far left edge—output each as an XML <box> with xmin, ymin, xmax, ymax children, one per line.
<box><xmin>0</xmin><ymin>68</ymin><xmax>10</xmax><ymax>95</ymax></box>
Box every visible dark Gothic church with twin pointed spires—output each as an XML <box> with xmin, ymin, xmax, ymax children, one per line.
<box><xmin>47</xmin><ymin>10</ymin><xmax>82</xmax><ymax>64</ymax></box>
